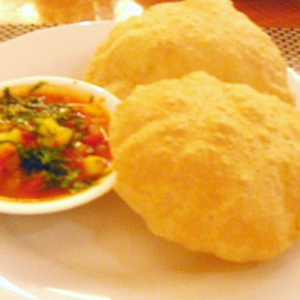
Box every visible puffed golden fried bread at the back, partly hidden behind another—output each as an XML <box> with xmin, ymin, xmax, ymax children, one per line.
<box><xmin>86</xmin><ymin>0</ymin><xmax>294</xmax><ymax>103</ymax></box>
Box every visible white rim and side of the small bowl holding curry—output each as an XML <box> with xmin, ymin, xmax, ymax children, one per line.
<box><xmin>0</xmin><ymin>76</ymin><xmax>120</xmax><ymax>215</ymax></box>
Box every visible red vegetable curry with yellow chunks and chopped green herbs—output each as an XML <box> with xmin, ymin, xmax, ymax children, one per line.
<box><xmin>0</xmin><ymin>83</ymin><xmax>112</xmax><ymax>201</ymax></box>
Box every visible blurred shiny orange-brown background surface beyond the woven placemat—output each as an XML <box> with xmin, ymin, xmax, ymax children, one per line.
<box><xmin>0</xmin><ymin>0</ymin><xmax>300</xmax><ymax>28</ymax></box>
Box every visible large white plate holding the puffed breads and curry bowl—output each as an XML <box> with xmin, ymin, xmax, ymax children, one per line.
<box><xmin>0</xmin><ymin>22</ymin><xmax>300</xmax><ymax>300</ymax></box>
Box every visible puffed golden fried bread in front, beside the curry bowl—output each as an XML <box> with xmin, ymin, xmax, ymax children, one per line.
<box><xmin>110</xmin><ymin>72</ymin><xmax>300</xmax><ymax>262</ymax></box>
